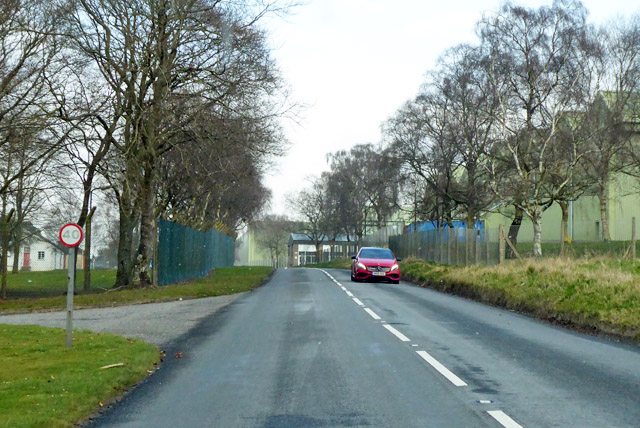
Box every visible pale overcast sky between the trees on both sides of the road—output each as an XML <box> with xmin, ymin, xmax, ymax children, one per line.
<box><xmin>266</xmin><ymin>0</ymin><xmax>640</xmax><ymax>215</ymax></box>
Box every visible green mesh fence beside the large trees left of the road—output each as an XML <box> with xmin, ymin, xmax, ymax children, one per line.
<box><xmin>157</xmin><ymin>219</ymin><xmax>235</xmax><ymax>285</ymax></box>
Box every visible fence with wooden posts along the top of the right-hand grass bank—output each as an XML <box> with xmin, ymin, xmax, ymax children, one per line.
<box><xmin>389</xmin><ymin>217</ymin><xmax>638</xmax><ymax>266</ymax></box>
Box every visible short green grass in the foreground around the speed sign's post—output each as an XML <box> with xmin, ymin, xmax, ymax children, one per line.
<box><xmin>0</xmin><ymin>325</ymin><xmax>160</xmax><ymax>428</ymax></box>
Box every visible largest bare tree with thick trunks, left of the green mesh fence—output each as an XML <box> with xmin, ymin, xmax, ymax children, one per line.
<box><xmin>69</xmin><ymin>0</ymin><xmax>290</xmax><ymax>285</ymax></box>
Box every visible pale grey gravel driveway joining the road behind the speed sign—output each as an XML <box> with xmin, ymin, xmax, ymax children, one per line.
<box><xmin>0</xmin><ymin>293</ymin><xmax>245</xmax><ymax>346</ymax></box>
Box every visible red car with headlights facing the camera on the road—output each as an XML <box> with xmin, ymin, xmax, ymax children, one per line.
<box><xmin>351</xmin><ymin>247</ymin><xmax>401</xmax><ymax>284</ymax></box>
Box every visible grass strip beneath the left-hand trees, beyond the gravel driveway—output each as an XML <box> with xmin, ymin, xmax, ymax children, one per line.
<box><xmin>0</xmin><ymin>266</ymin><xmax>273</xmax><ymax>313</ymax></box>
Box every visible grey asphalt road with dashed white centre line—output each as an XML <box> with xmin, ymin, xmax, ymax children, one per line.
<box><xmin>84</xmin><ymin>269</ymin><xmax>640</xmax><ymax>428</ymax></box>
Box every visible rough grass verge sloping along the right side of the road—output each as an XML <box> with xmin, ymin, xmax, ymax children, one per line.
<box><xmin>401</xmin><ymin>257</ymin><xmax>640</xmax><ymax>340</ymax></box>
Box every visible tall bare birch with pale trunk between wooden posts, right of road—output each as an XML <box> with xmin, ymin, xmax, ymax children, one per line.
<box><xmin>478</xmin><ymin>0</ymin><xmax>588</xmax><ymax>257</ymax></box>
